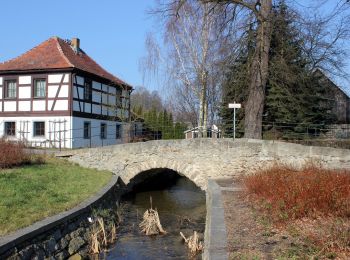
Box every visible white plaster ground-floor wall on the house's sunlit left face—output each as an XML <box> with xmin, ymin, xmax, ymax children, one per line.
<box><xmin>0</xmin><ymin>116</ymin><xmax>71</xmax><ymax>148</ymax></box>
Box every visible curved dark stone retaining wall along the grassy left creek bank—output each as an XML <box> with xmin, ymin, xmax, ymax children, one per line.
<box><xmin>0</xmin><ymin>176</ymin><xmax>122</xmax><ymax>260</ymax></box>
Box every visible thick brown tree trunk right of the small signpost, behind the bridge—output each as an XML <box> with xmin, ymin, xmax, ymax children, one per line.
<box><xmin>244</xmin><ymin>0</ymin><xmax>272</xmax><ymax>139</ymax></box>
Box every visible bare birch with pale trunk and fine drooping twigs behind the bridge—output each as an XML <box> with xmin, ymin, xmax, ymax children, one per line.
<box><xmin>142</xmin><ymin>0</ymin><xmax>228</xmax><ymax>134</ymax></box>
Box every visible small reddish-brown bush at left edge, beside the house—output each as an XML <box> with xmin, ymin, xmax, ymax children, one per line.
<box><xmin>0</xmin><ymin>139</ymin><xmax>31</xmax><ymax>168</ymax></box>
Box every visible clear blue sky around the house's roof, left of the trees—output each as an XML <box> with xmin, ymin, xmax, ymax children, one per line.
<box><xmin>0</xmin><ymin>0</ymin><xmax>350</xmax><ymax>95</ymax></box>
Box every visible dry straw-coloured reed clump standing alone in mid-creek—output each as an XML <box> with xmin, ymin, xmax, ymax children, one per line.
<box><xmin>139</xmin><ymin>197</ymin><xmax>166</xmax><ymax>236</ymax></box>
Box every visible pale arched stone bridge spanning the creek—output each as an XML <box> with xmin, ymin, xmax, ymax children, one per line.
<box><xmin>61</xmin><ymin>139</ymin><xmax>350</xmax><ymax>190</ymax></box>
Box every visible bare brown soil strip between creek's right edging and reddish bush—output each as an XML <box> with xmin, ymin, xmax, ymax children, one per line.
<box><xmin>218</xmin><ymin>181</ymin><xmax>318</xmax><ymax>259</ymax></box>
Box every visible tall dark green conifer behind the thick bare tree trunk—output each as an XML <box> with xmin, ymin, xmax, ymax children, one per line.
<box><xmin>221</xmin><ymin>0</ymin><xmax>332</xmax><ymax>138</ymax></box>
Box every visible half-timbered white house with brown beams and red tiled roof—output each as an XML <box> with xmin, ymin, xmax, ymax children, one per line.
<box><xmin>0</xmin><ymin>37</ymin><xmax>132</xmax><ymax>148</ymax></box>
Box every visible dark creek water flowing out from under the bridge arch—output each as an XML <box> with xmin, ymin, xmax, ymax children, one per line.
<box><xmin>105</xmin><ymin>172</ymin><xmax>206</xmax><ymax>260</ymax></box>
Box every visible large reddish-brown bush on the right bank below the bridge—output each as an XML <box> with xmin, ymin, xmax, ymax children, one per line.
<box><xmin>244</xmin><ymin>164</ymin><xmax>350</xmax><ymax>220</ymax></box>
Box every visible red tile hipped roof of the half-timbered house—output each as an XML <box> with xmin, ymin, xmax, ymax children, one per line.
<box><xmin>0</xmin><ymin>37</ymin><xmax>131</xmax><ymax>87</ymax></box>
